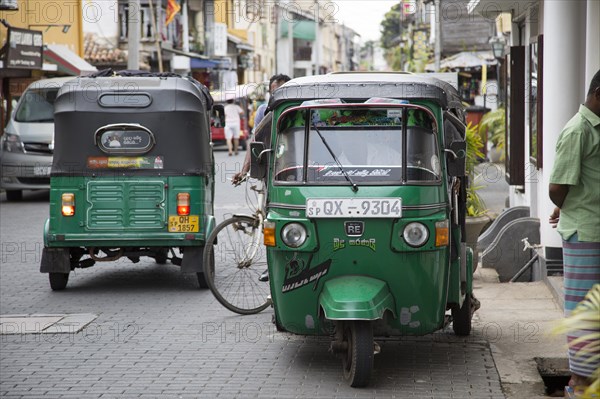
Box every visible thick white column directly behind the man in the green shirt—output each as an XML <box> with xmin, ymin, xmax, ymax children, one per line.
<box><xmin>537</xmin><ymin>0</ymin><xmax>584</xmax><ymax>247</ymax></box>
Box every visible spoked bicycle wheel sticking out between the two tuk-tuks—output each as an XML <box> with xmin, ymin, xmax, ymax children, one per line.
<box><xmin>204</xmin><ymin>216</ymin><xmax>270</xmax><ymax>315</ymax></box>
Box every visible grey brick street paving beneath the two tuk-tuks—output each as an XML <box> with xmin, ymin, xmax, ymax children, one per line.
<box><xmin>0</xmin><ymin>152</ymin><xmax>505</xmax><ymax>399</ymax></box>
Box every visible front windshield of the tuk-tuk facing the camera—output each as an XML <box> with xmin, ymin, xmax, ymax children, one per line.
<box><xmin>275</xmin><ymin>104</ymin><xmax>440</xmax><ymax>184</ymax></box>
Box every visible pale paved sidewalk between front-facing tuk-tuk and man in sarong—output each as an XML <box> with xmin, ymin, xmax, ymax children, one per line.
<box><xmin>474</xmin><ymin>268</ymin><xmax>566</xmax><ymax>399</ymax></box>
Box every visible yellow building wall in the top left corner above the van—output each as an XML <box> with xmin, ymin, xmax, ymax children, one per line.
<box><xmin>0</xmin><ymin>0</ymin><xmax>83</xmax><ymax>57</ymax></box>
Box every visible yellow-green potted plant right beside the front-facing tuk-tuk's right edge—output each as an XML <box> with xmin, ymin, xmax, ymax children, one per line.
<box><xmin>465</xmin><ymin>123</ymin><xmax>490</xmax><ymax>270</ymax></box>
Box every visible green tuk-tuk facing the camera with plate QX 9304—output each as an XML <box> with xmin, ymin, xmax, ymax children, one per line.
<box><xmin>251</xmin><ymin>73</ymin><xmax>477</xmax><ymax>387</ymax></box>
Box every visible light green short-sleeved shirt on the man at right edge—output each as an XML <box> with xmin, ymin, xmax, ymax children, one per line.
<box><xmin>550</xmin><ymin>105</ymin><xmax>600</xmax><ymax>242</ymax></box>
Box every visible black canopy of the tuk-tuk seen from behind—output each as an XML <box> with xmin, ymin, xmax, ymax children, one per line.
<box><xmin>52</xmin><ymin>75</ymin><xmax>212</xmax><ymax>176</ymax></box>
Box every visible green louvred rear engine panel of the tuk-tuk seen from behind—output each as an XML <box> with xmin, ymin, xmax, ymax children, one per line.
<box><xmin>87</xmin><ymin>181</ymin><xmax>166</xmax><ymax>230</ymax></box>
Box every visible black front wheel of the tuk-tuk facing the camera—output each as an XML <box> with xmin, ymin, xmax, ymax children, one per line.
<box><xmin>341</xmin><ymin>321</ymin><xmax>374</xmax><ymax>388</ymax></box>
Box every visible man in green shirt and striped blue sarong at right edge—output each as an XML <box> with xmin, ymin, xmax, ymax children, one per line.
<box><xmin>549</xmin><ymin>71</ymin><xmax>600</xmax><ymax>393</ymax></box>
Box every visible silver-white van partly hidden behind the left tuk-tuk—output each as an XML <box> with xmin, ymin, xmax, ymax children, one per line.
<box><xmin>0</xmin><ymin>77</ymin><xmax>73</xmax><ymax>201</ymax></box>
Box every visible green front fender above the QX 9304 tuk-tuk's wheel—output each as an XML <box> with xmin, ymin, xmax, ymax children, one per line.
<box><xmin>319</xmin><ymin>276</ymin><xmax>397</xmax><ymax>320</ymax></box>
